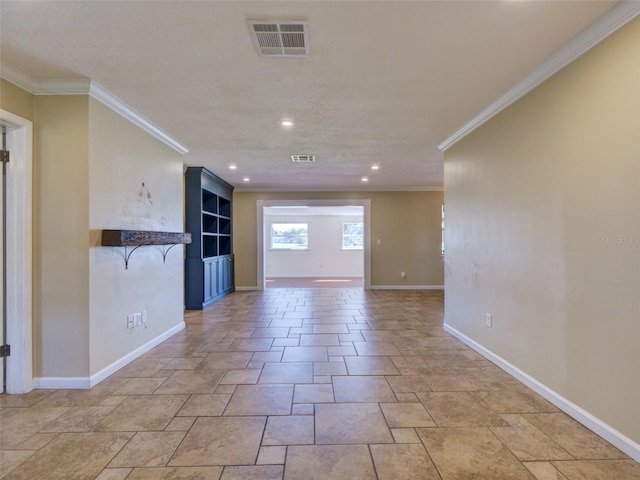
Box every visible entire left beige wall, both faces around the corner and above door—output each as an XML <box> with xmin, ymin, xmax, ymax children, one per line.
<box><xmin>7</xmin><ymin>80</ymin><xmax>184</xmax><ymax>378</ymax></box>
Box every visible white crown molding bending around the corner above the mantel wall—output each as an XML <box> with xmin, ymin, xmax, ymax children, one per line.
<box><xmin>0</xmin><ymin>64</ymin><xmax>189</xmax><ymax>155</ymax></box>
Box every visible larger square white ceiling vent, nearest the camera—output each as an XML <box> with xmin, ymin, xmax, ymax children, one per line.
<box><xmin>249</xmin><ymin>20</ymin><xmax>309</xmax><ymax>57</ymax></box>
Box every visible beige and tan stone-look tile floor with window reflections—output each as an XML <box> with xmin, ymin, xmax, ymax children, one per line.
<box><xmin>0</xmin><ymin>289</ymin><xmax>640</xmax><ymax>480</ymax></box>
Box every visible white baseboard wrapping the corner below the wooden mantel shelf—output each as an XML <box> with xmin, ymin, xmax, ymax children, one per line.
<box><xmin>33</xmin><ymin>322</ymin><xmax>185</xmax><ymax>390</ymax></box>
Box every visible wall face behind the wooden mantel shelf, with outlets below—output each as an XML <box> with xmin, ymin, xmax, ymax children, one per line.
<box><xmin>88</xmin><ymin>99</ymin><xmax>184</xmax><ymax>375</ymax></box>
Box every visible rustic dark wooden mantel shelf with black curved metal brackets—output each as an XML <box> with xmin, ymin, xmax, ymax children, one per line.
<box><xmin>102</xmin><ymin>230</ymin><xmax>191</xmax><ymax>269</ymax></box>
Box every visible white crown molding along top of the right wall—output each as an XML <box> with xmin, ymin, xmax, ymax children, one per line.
<box><xmin>438</xmin><ymin>0</ymin><xmax>640</xmax><ymax>152</ymax></box>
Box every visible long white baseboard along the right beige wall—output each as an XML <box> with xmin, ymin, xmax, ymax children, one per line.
<box><xmin>444</xmin><ymin>323</ymin><xmax>640</xmax><ymax>462</ymax></box>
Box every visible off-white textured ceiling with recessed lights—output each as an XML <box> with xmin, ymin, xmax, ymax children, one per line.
<box><xmin>0</xmin><ymin>0</ymin><xmax>616</xmax><ymax>190</ymax></box>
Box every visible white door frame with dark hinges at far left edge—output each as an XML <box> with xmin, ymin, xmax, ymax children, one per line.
<box><xmin>0</xmin><ymin>109</ymin><xmax>33</xmax><ymax>393</ymax></box>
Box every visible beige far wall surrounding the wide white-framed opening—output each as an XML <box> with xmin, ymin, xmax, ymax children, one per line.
<box><xmin>233</xmin><ymin>192</ymin><xmax>443</xmax><ymax>287</ymax></box>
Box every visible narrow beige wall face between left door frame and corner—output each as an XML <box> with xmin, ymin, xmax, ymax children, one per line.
<box><xmin>33</xmin><ymin>96</ymin><xmax>89</xmax><ymax>377</ymax></box>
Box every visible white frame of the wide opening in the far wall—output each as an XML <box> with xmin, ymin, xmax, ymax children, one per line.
<box><xmin>256</xmin><ymin>198</ymin><xmax>371</xmax><ymax>290</ymax></box>
